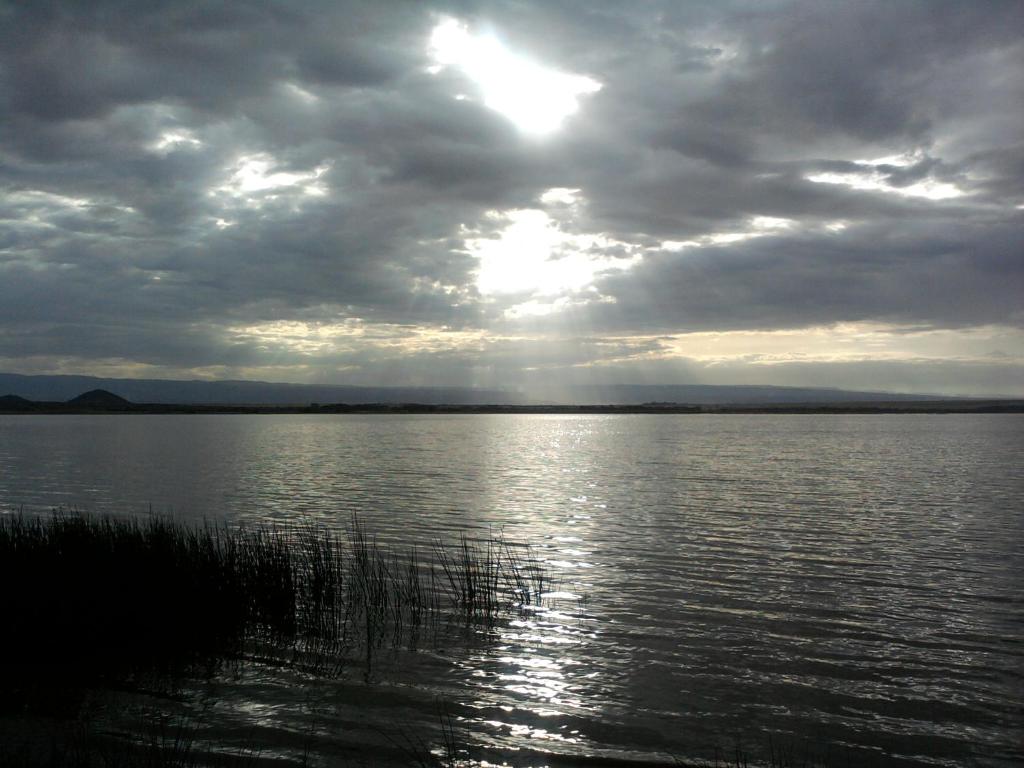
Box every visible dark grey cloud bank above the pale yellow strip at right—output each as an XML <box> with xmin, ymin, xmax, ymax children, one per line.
<box><xmin>588</xmin><ymin>215</ymin><xmax>1024</xmax><ymax>331</ymax></box>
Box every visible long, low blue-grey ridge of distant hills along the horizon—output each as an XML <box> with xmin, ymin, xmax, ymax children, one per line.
<box><xmin>0</xmin><ymin>374</ymin><xmax>974</xmax><ymax>412</ymax></box>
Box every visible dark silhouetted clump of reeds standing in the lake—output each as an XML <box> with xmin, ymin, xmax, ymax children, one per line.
<box><xmin>0</xmin><ymin>512</ymin><xmax>540</xmax><ymax>708</ymax></box>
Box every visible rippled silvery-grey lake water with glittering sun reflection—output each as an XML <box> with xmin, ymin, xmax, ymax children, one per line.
<box><xmin>0</xmin><ymin>415</ymin><xmax>1024</xmax><ymax>766</ymax></box>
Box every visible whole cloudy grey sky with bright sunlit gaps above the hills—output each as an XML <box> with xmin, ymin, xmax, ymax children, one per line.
<box><xmin>0</xmin><ymin>0</ymin><xmax>1024</xmax><ymax>396</ymax></box>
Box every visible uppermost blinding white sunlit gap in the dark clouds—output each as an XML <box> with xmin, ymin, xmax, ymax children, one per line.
<box><xmin>429</xmin><ymin>18</ymin><xmax>602</xmax><ymax>135</ymax></box>
